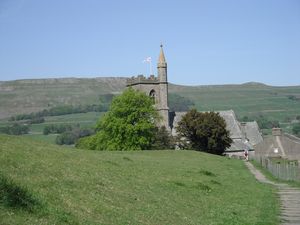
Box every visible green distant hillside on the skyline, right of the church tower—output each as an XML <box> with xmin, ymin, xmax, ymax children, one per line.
<box><xmin>170</xmin><ymin>83</ymin><xmax>300</xmax><ymax>122</ymax></box>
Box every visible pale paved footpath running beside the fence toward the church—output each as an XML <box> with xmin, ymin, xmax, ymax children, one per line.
<box><xmin>245</xmin><ymin>162</ymin><xmax>300</xmax><ymax>225</ymax></box>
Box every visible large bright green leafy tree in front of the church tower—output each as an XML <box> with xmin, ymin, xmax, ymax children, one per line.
<box><xmin>86</xmin><ymin>88</ymin><xmax>158</xmax><ymax>150</ymax></box>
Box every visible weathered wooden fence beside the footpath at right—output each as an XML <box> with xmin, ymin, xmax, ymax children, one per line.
<box><xmin>254</xmin><ymin>156</ymin><xmax>300</xmax><ymax>181</ymax></box>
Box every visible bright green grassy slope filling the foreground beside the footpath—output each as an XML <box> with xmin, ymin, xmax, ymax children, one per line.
<box><xmin>0</xmin><ymin>135</ymin><xmax>278</xmax><ymax>225</ymax></box>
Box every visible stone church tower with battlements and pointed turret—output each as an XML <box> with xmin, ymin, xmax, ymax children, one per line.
<box><xmin>126</xmin><ymin>45</ymin><xmax>170</xmax><ymax>129</ymax></box>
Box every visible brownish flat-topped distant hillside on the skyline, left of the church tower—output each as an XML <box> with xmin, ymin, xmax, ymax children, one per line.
<box><xmin>0</xmin><ymin>77</ymin><xmax>126</xmax><ymax>118</ymax></box>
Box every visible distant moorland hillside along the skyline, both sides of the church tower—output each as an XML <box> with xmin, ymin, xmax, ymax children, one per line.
<box><xmin>0</xmin><ymin>77</ymin><xmax>300</xmax><ymax>122</ymax></box>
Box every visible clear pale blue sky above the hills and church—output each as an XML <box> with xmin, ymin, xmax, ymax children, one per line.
<box><xmin>0</xmin><ymin>0</ymin><xmax>300</xmax><ymax>86</ymax></box>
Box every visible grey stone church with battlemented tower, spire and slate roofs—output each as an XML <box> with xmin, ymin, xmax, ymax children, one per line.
<box><xmin>126</xmin><ymin>45</ymin><xmax>263</xmax><ymax>156</ymax></box>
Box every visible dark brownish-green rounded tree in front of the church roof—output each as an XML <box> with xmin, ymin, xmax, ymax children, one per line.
<box><xmin>176</xmin><ymin>109</ymin><xmax>232</xmax><ymax>155</ymax></box>
